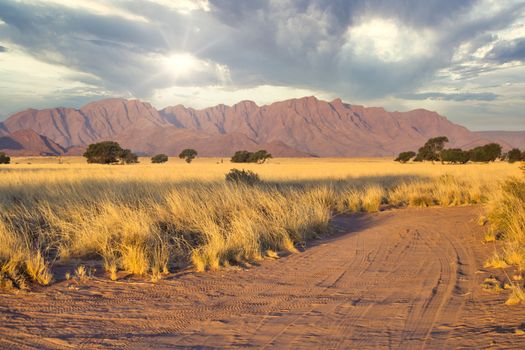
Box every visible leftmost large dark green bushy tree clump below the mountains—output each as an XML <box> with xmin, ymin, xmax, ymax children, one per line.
<box><xmin>84</xmin><ymin>141</ymin><xmax>138</xmax><ymax>164</ymax></box>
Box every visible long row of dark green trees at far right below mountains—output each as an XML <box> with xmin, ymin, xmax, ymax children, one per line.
<box><xmin>395</xmin><ymin>136</ymin><xmax>525</xmax><ymax>164</ymax></box>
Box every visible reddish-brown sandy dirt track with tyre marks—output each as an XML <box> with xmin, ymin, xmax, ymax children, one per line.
<box><xmin>0</xmin><ymin>207</ymin><xmax>525</xmax><ymax>349</ymax></box>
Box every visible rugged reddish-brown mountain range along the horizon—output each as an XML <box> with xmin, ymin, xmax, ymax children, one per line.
<box><xmin>0</xmin><ymin>96</ymin><xmax>525</xmax><ymax>157</ymax></box>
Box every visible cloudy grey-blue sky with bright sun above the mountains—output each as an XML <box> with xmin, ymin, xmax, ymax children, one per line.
<box><xmin>0</xmin><ymin>0</ymin><xmax>525</xmax><ymax>130</ymax></box>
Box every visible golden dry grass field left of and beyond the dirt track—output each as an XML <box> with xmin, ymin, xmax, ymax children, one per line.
<box><xmin>0</xmin><ymin>158</ymin><xmax>523</xmax><ymax>288</ymax></box>
